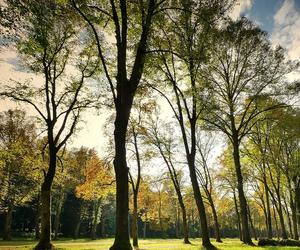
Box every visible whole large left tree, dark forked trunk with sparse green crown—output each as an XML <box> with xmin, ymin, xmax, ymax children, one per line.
<box><xmin>1</xmin><ymin>0</ymin><xmax>98</xmax><ymax>249</ymax></box>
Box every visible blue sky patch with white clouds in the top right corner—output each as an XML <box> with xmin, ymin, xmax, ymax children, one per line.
<box><xmin>231</xmin><ymin>0</ymin><xmax>300</xmax><ymax>59</ymax></box>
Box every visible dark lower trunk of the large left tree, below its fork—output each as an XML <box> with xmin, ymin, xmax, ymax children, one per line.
<box><xmin>35</xmin><ymin>146</ymin><xmax>57</xmax><ymax>250</ymax></box>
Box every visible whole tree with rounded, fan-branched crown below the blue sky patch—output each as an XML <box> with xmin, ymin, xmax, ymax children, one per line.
<box><xmin>200</xmin><ymin>18</ymin><xmax>291</xmax><ymax>244</ymax></box>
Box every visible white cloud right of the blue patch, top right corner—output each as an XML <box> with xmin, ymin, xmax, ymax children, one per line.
<box><xmin>271</xmin><ymin>0</ymin><xmax>300</xmax><ymax>59</ymax></box>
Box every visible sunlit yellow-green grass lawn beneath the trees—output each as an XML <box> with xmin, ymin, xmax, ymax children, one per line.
<box><xmin>0</xmin><ymin>239</ymin><xmax>300</xmax><ymax>250</ymax></box>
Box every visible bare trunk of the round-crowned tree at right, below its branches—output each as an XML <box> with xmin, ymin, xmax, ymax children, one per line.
<box><xmin>233</xmin><ymin>140</ymin><xmax>253</xmax><ymax>245</ymax></box>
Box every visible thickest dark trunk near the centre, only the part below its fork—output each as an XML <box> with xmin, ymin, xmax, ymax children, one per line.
<box><xmin>110</xmin><ymin>94</ymin><xmax>133</xmax><ymax>250</ymax></box>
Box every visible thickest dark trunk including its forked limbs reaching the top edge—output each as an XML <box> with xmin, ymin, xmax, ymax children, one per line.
<box><xmin>110</xmin><ymin>0</ymin><xmax>156</xmax><ymax>247</ymax></box>
